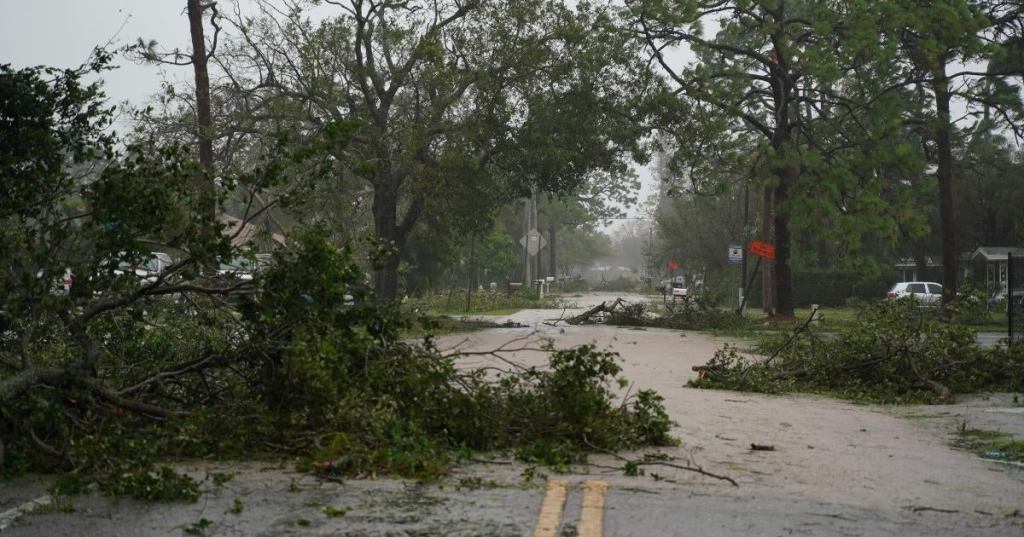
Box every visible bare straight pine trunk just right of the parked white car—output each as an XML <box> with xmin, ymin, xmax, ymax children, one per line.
<box><xmin>932</xmin><ymin>67</ymin><xmax>956</xmax><ymax>303</ymax></box>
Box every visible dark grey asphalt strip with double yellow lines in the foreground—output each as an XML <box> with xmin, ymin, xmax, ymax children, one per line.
<box><xmin>2</xmin><ymin>467</ymin><xmax>1024</xmax><ymax>537</ymax></box>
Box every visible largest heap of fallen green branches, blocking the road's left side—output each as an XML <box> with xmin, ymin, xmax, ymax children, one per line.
<box><xmin>0</xmin><ymin>235</ymin><xmax>672</xmax><ymax>499</ymax></box>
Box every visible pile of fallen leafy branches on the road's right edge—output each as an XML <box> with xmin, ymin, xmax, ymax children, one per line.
<box><xmin>691</xmin><ymin>299</ymin><xmax>1024</xmax><ymax>402</ymax></box>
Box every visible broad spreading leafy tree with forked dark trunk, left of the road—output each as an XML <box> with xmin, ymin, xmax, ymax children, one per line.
<box><xmin>168</xmin><ymin>0</ymin><xmax>649</xmax><ymax>298</ymax></box>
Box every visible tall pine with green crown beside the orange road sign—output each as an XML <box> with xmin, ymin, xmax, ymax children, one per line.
<box><xmin>627</xmin><ymin>0</ymin><xmax>925</xmax><ymax>315</ymax></box>
